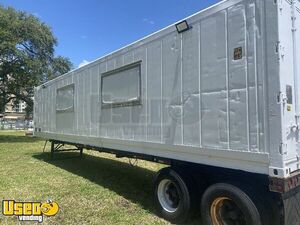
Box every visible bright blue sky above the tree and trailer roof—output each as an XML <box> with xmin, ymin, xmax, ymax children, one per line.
<box><xmin>0</xmin><ymin>0</ymin><xmax>218</xmax><ymax>67</ymax></box>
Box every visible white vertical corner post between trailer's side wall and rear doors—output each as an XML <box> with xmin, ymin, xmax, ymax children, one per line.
<box><xmin>261</xmin><ymin>1</ymin><xmax>284</xmax><ymax>177</ymax></box>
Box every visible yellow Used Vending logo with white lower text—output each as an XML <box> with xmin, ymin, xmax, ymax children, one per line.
<box><xmin>2</xmin><ymin>200</ymin><xmax>59</xmax><ymax>223</ymax></box>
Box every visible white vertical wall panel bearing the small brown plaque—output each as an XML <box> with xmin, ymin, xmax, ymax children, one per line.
<box><xmin>228</xmin><ymin>4</ymin><xmax>249</xmax><ymax>150</ymax></box>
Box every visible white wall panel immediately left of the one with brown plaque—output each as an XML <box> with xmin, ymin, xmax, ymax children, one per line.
<box><xmin>200</xmin><ymin>11</ymin><xmax>229</xmax><ymax>149</ymax></box>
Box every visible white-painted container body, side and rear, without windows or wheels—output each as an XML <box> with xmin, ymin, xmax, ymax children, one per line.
<box><xmin>35</xmin><ymin>0</ymin><xmax>300</xmax><ymax>177</ymax></box>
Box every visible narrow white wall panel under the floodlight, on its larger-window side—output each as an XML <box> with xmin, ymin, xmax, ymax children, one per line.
<box><xmin>161</xmin><ymin>32</ymin><xmax>183</xmax><ymax>145</ymax></box>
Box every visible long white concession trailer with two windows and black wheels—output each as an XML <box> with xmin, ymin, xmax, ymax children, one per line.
<box><xmin>34</xmin><ymin>0</ymin><xmax>300</xmax><ymax>225</ymax></box>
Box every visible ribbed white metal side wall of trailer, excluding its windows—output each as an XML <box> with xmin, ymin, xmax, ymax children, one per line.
<box><xmin>35</xmin><ymin>0</ymin><xmax>265</xmax><ymax>152</ymax></box>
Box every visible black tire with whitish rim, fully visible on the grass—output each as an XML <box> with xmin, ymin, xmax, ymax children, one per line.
<box><xmin>154</xmin><ymin>168</ymin><xmax>196</xmax><ymax>224</ymax></box>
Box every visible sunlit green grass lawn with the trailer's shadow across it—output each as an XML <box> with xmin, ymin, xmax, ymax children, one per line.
<box><xmin>0</xmin><ymin>131</ymin><xmax>202</xmax><ymax>225</ymax></box>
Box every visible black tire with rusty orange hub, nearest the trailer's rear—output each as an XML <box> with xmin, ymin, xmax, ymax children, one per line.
<box><xmin>201</xmin><ymin>183</ymin><xmax>268</xmax><ymax>225</ymax></box>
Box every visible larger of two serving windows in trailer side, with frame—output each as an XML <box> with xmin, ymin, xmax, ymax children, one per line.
<box><xmin>101</xmin><ymin>61</ymin><xmax>141</xmax><ymax>108</ymax></box>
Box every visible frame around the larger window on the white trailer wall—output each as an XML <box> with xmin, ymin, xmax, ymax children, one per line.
<box><xmin>100</xmin><ymin>60</ymin><xmax>142</xmax><ymax>109</ymax></box>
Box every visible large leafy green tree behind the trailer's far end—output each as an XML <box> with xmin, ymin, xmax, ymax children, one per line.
<box><xmin>0</xmin><ymin>5</ymin><xmax>72</xmax><ymax>116</ymax></box>
